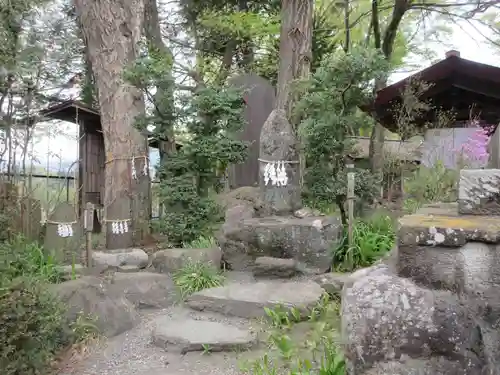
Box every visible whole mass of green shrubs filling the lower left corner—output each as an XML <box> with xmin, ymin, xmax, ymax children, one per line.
<box><xmin>0</xmin><ymin>236</ymin><xmax>96</xmax><ymax>375</ymax></box>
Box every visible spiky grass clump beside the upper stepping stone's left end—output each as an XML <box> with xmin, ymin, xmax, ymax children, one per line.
<box><xmin>173</xmin><ymin>262</ymin><xmax>225</xmax><ymax>299</ymax></box>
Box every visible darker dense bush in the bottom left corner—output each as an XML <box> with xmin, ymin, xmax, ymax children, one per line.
<box><xmin>0</xmin><ymin>276</ymin><xmax>70</xmax><ymax>375</ymax></box>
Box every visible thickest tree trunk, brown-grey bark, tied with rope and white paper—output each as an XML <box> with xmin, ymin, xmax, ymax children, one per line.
<box><xmin>74</xmin><ymin>0</ymin><xmax>151</xmax><ymax>249</ymax></box>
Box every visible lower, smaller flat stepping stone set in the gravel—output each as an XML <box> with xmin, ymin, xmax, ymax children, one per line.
<box><xmin>153</xmin><ymin>316</ymin><xmax>256</xmax><ymax>354</ymax></box>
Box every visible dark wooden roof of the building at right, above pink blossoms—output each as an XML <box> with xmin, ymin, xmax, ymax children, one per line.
<box><xmin>363</xmin><ymin>51</ymin><xmax>500</xmax><ymax>132</ymax></box>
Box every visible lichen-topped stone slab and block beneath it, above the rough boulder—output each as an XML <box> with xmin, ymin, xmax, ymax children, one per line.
<box><xmin>397</xmin><ymin>209</ymin><xmax>500</xmax><ymax>293</ymax></box>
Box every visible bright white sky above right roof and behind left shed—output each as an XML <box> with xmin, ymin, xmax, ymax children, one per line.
<box><xmin>22</xmin><ymin>18</ymin><xmax>500</xmax><ymax>175</ymax></box>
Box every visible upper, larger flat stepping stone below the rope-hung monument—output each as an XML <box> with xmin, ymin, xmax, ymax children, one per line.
<box><xmin>186</xmin><ymin>280</ymin><xmax>325</xmax><ymax>319</ymax></box>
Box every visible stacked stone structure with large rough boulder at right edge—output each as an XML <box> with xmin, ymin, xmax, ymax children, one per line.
<box><xmin>341</xmin><ymin>169</ymin><xmax>500</xmax><ymax>375</ymax></box>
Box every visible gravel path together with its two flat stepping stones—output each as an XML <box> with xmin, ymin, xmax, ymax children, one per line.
<box><xmin>60</xmin><ymin>281</ymin><xmax>323</xmax><ymax>375</ymax></box>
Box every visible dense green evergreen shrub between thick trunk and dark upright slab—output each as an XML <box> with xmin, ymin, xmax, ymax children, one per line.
<box><xmin>158</xmin><ymin>88</ymin><xmax>247</xmax><ymax>246</ymax></box>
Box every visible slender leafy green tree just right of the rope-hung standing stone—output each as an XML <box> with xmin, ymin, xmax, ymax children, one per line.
<box><xmin>296</xmin><ymin>49</ymin><xmax>387</xmax><ymax>223</ymax></box>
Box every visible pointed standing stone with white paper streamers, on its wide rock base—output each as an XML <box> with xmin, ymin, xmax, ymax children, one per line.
<box><xmin>217</xmin><ymin>84</ymin><xmax>342</xmax><ymax>277</ymax></box>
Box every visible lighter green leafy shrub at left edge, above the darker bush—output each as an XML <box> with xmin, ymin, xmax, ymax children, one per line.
<box><xmin>0</xmin><ymin>235</ymin><xmax>62</xmax><ymax>283</ymax></box>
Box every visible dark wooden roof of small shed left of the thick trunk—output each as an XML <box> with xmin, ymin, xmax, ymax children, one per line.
<box><xmin>38</xmin><ymin>100</ymin><xmax>182</xmax><ymax>148</ymax></box>
